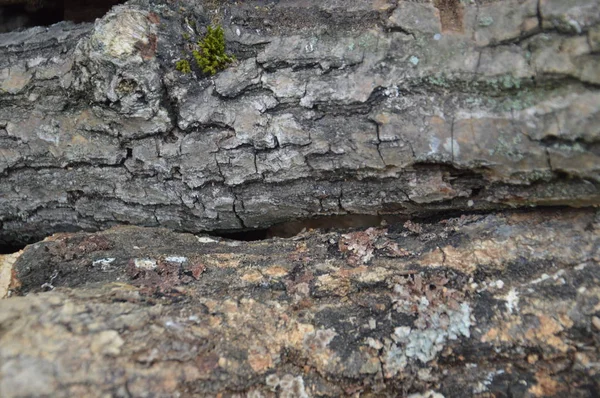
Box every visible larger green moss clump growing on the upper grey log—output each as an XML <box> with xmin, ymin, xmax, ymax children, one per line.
<box><xmin>192</xmin><ymin>26</ymin><xmax>235</xmax><ymax>75</ymax></box>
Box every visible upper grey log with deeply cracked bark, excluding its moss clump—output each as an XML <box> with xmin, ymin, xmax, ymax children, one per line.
<box><xmin>0</xmin><ymin>0</ymin><xmax>600</xmax><ymax>246</ymax></box>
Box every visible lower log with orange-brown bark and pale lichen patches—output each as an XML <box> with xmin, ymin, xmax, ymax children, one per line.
<box><xmin>0</xmin><ymin>210</ymin><xmax>600</xmax><ymax>397</ymax></box>
